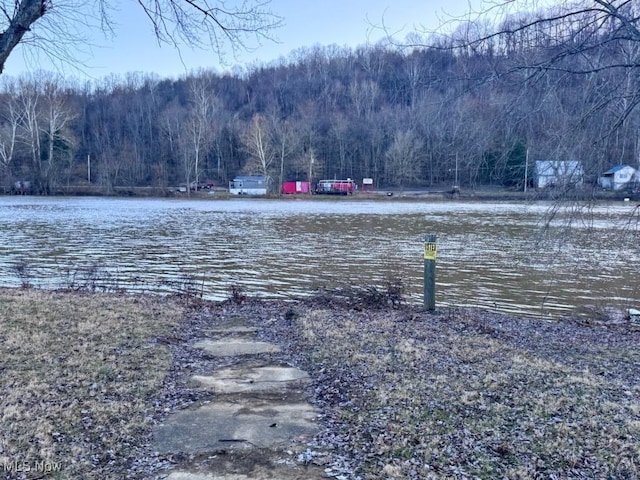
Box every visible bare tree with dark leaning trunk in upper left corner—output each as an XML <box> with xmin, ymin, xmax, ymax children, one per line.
<box><xmin>0</xmin><ymin>0</ymin><xmax>281</xmax><ymax>73</ymax></box>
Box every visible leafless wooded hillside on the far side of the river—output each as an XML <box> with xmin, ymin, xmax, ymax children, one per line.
<box><xmin>0</xmin><ymin>4</ymin><xmax>640</xmax><ymax>194</ymax></box>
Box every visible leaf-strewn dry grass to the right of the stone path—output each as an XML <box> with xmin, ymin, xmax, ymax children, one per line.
<box><xmin>262</xmin><ymin>307</ymin><xmax>640</xmax><ymax>479</ymax></box>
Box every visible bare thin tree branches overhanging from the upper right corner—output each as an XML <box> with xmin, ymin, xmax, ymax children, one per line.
<box><xmin>422</xmin><ymin>0</ymin><xmax>640</xmax><ymax>138</ymax></box>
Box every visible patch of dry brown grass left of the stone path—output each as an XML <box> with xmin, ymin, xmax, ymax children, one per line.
<box><xmin>0</xmin><ymin>290</ymin><xmax>184</xmax><ymax>480</ymax></box>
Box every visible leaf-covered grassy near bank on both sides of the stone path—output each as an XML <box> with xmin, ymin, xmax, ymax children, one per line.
<box><xmin>0</xmin><ymin>289</ymin><xmax>640</xmax><ymax>480</ymax></box>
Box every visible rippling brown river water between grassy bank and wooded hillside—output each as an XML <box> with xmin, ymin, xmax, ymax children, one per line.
<box><xmin>0</xmin><ymin>197</ymin><xmax>640</xmax><ymax>318</ymax></box>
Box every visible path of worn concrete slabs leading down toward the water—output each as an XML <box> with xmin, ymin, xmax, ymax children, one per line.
<box><xmin>153</xmin><ymin>319</ymin><xmax>328</xmax><ymax>480</ymax></box>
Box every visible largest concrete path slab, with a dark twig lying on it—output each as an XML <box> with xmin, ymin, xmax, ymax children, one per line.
<box><xmin>153</xmin><ymin>398</ymin><xmax>318</xmax><ymax>453</ymax></box>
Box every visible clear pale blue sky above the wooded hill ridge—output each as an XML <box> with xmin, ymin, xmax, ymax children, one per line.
<box><xmin>3</xmin><ymin>0</ymin><xmax>476</xmax><ymax>80</ymax></box>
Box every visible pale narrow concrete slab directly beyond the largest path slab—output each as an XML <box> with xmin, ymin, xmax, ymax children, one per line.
<box><xmin>191</xmin><ymin>366</ymin><xmax>310</xmax><ymax>393</ymax></box>
